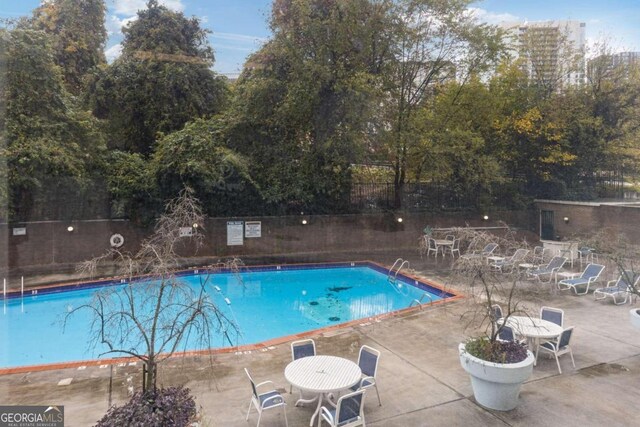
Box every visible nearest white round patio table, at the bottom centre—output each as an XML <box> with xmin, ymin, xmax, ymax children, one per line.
<box><xmin>284</xmin><ymin>355</ymin><xmax>362</xmax><ymax>426</ymax></box>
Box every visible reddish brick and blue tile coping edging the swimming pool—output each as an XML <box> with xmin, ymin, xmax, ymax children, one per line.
<box><xmin>0</xmin><ymin>260</ymin><xmax>464</xmax><ymax>375</ymax></box>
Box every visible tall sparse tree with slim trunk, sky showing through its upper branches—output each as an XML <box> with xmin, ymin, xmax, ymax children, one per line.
<box><xmin>382</xmin><ymin>0</ymin><xmax>504</xmax><ymax>207</ymax></box>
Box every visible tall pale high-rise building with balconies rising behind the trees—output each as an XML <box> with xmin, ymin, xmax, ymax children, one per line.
<box><xmin>500</xmin><ymin>21</ymin><xmax>586</xmax><ymax>90</ymax></box>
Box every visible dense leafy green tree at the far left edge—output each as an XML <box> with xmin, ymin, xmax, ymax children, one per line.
<box><xmin>0</xmin><ymin>29</ymin><xmax>105</xmax><ymax>218</ymax></box>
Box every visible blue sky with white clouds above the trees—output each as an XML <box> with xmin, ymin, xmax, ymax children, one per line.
<box><xmin>0</xmin><ymin>0</ymin><xmax>640</xmax><ymax>76</ymax></box>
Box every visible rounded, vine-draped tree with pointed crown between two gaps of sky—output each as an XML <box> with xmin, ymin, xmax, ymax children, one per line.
<box><xmin>88</xmin><ymin>0</ymin><xmax>227</xmax><ymax>155</ymax></box>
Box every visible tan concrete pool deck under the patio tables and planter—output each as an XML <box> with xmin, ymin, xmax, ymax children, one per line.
<box><xmin>0</xmin><ymin>252</ymin><xmax>640</xmax><ymax>427</ymax></box>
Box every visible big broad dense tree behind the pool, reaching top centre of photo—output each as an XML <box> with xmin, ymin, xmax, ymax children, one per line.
<box><xmin>231</xmin><ymin>0</ymin><xmax>392</xmax><ymax>211</ymax></box>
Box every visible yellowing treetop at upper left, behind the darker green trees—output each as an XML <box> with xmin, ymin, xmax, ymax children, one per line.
<box><xmin>29</xmin><ymin>0</ymin><xmax>107</xmax><ymax>95</ymax></box>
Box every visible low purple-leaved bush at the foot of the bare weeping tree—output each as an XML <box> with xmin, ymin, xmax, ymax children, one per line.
<box><xmin>96</xmin><ymin>387</ymin><xmax>196</xmax><ymax>427</ymax></box>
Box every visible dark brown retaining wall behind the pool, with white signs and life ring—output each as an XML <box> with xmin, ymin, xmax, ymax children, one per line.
<box><xmin>0</xmin><ymin>211</ymin><xmax>537</xmax><ymax>277</ymax></box>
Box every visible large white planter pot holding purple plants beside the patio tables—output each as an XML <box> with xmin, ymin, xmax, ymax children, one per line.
<box><xmin>458</xmin><ymin>344</ymin><xmax>535</xmax><ymax>411</ymax></box>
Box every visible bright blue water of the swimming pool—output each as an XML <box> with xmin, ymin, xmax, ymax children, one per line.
<box><xmin>0</xmin><ymin>266</ymin><xmax>450</xmax><ymax>368</ymax></box>
